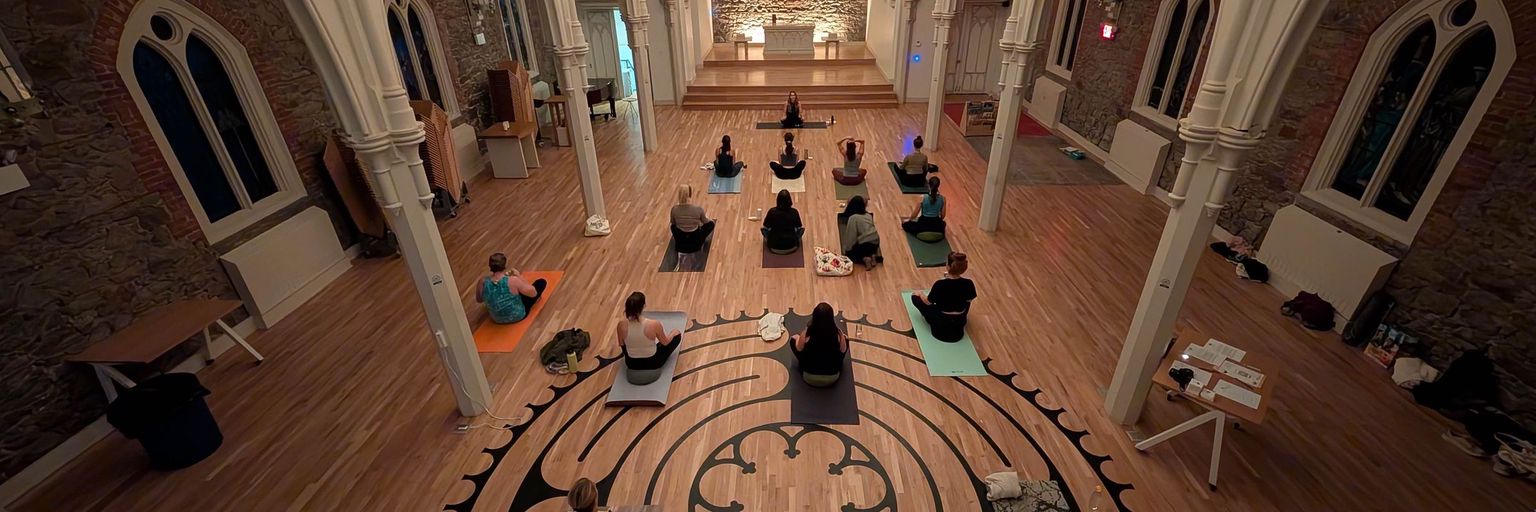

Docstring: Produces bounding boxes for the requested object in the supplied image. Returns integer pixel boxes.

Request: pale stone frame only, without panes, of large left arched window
[117,0,306,244]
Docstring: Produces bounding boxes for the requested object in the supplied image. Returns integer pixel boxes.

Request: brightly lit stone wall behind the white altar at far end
[713,0,866,43]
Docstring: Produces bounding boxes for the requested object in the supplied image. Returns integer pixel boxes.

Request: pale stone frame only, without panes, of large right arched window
[1301,0,1516,244]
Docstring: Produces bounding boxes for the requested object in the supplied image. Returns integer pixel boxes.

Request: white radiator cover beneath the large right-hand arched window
[1258,204,1398,322]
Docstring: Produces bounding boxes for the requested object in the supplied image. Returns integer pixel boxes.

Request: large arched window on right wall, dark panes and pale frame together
[1306,0,1514,243]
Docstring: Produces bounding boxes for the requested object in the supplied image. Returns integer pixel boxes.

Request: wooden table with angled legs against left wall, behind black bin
[65,298,263,401]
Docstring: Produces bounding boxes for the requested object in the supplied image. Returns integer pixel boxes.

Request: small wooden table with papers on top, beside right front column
[1137,331,1284,489]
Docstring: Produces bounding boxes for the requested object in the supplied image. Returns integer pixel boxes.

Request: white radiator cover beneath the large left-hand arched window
[220,206,352,329]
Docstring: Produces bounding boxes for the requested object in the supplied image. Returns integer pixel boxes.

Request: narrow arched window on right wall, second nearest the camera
[1135,0,1215,126]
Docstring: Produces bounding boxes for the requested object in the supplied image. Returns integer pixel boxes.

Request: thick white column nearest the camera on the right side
[1104,0,1326,424]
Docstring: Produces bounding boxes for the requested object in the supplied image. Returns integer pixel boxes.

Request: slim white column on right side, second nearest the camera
[976,0,1044,232]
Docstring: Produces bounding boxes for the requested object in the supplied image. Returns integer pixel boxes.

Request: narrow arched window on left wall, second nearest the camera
[384,0,459,115]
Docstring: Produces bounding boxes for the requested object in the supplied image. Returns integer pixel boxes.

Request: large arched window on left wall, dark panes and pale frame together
[117,0,304,241]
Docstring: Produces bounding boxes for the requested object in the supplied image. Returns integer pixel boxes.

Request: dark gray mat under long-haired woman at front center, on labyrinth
[782,315,859,424]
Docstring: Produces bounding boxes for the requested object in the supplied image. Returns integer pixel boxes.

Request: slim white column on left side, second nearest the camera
[550,0,608,220]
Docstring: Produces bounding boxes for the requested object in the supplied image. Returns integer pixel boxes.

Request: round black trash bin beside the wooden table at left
[106,374,224,469]
